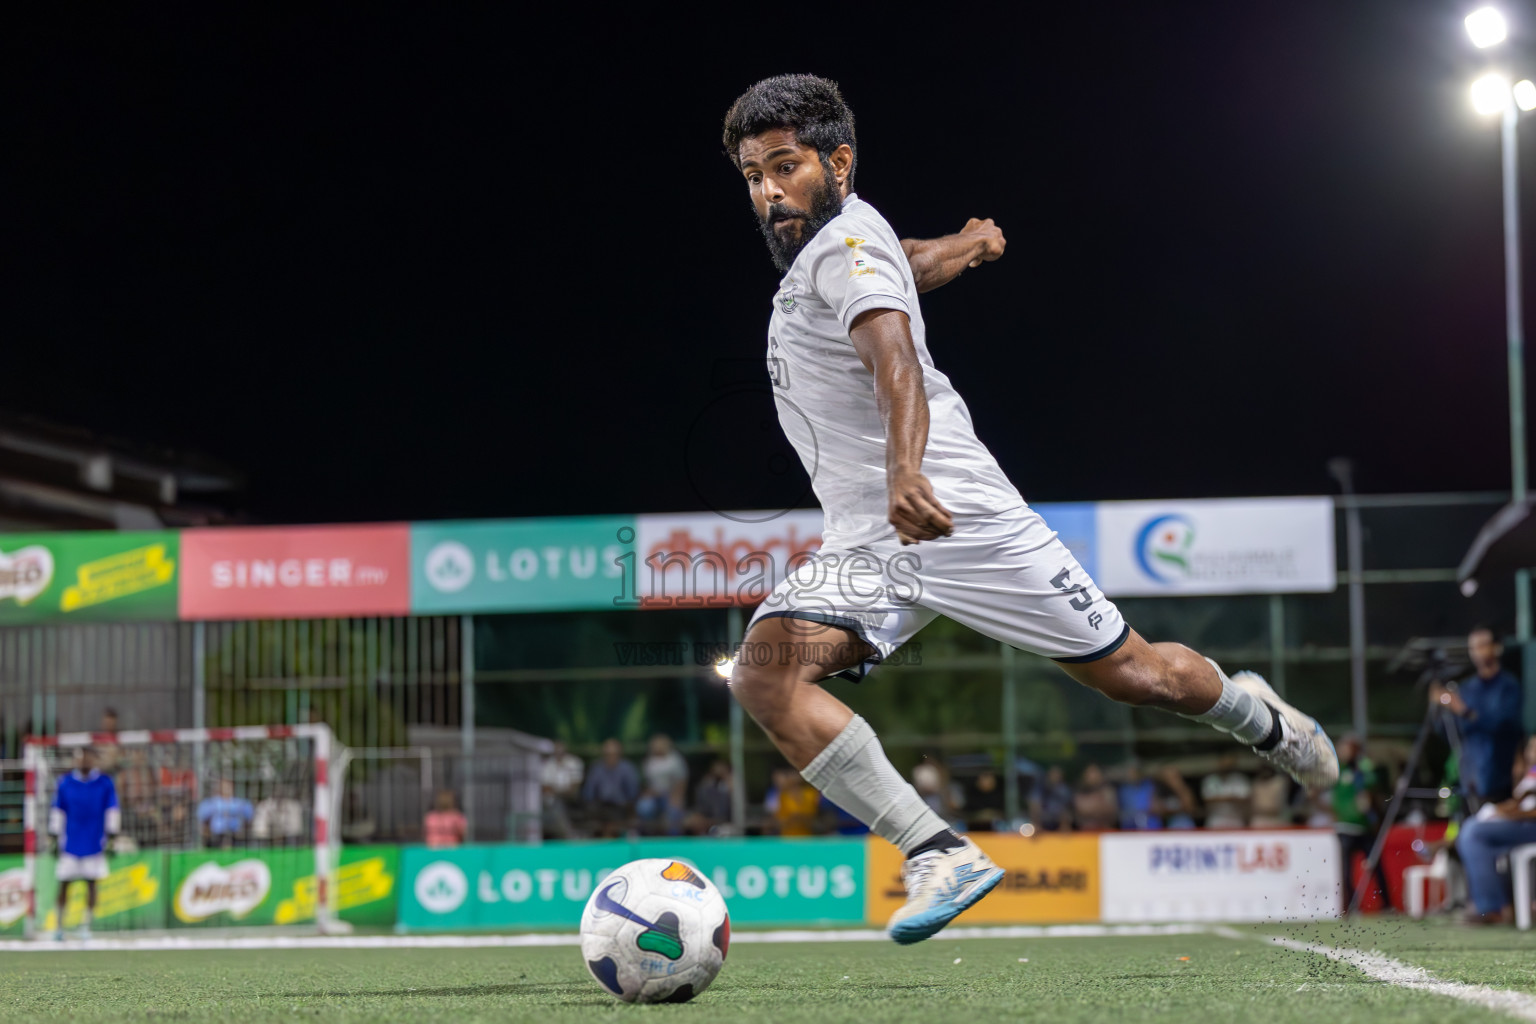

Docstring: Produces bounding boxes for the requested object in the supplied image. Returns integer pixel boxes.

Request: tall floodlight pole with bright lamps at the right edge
[1465,8,1536,645]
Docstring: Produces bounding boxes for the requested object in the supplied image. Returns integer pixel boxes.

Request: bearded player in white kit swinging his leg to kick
[722,75,1338,943]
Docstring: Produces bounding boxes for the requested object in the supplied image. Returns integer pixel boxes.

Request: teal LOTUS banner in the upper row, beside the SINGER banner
[410,516,639,616]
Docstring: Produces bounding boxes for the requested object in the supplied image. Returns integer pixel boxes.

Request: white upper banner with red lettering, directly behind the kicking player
[634,508,822,608]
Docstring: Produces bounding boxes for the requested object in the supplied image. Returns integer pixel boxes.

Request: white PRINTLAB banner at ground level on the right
[1098,829,1341,921]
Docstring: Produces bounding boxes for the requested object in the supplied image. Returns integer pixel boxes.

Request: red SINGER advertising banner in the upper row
[181,524,410,619]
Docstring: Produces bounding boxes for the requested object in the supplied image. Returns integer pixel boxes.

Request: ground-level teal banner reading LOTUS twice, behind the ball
[399,837,865,930]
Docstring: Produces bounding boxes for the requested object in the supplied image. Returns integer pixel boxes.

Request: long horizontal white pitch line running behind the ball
[0,924,1210,953]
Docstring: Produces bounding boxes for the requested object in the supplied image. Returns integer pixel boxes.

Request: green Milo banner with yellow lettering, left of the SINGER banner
[0,530,180,625]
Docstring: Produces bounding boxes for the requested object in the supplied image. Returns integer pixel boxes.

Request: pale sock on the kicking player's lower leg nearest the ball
[800,715,949,855]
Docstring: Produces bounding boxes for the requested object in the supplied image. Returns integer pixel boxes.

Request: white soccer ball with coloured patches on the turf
[581,860,731,1003]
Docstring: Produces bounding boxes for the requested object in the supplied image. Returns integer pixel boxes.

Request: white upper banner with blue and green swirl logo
[1094,497,1338,597]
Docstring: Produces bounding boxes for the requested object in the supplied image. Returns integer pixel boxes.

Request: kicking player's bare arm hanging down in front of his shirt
[848,309,954,543]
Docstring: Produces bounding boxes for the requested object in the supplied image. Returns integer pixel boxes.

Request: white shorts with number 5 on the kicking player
[739,505,1130,680]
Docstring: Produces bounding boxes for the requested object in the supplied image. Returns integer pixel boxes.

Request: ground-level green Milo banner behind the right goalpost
[166,846,399,927]
